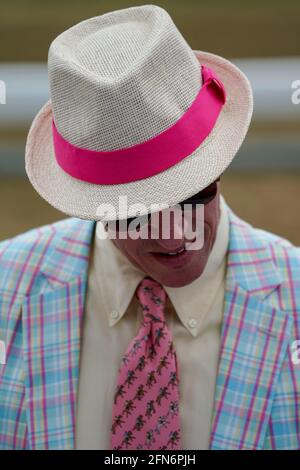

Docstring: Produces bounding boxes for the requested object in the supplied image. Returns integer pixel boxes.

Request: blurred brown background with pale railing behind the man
[0,0,300,245]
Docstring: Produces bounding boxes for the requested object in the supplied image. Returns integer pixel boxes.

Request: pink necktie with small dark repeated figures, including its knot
[111,277,181,450]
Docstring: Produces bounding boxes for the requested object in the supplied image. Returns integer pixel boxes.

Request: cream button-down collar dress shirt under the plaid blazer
[76,195,229,450]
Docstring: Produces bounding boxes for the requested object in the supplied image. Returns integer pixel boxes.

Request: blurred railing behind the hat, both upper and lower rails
[0,57,300,177]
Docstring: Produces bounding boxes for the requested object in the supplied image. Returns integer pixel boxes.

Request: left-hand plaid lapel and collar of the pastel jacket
[22,219,94,449]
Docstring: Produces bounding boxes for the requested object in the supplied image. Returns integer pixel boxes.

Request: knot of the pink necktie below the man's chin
[136,277,167,323]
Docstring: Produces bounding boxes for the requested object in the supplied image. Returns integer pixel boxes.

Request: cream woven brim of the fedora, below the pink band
[25,51,253,220]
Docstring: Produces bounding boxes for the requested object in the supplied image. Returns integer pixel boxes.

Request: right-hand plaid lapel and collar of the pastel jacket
[210,206,292,449]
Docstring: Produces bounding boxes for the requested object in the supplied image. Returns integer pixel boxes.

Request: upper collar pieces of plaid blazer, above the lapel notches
[40,205,282,299]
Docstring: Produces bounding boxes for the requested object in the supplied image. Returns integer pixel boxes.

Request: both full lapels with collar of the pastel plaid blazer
[23,206,291,449]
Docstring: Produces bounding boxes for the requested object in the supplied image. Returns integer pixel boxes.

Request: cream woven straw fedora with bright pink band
[25,5,253,220]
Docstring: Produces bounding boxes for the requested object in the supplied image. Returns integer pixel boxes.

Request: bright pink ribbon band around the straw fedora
[52,65,226,184]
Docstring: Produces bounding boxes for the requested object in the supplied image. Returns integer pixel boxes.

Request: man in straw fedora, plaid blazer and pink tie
[0,5,300,450]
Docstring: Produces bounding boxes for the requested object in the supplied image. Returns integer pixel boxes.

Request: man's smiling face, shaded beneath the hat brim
[112,179,220,287]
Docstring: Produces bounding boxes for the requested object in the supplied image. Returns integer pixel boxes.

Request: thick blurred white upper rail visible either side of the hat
[0,57,300,126]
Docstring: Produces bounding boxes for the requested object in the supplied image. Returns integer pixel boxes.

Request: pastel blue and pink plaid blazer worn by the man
[0,206,300,449]
